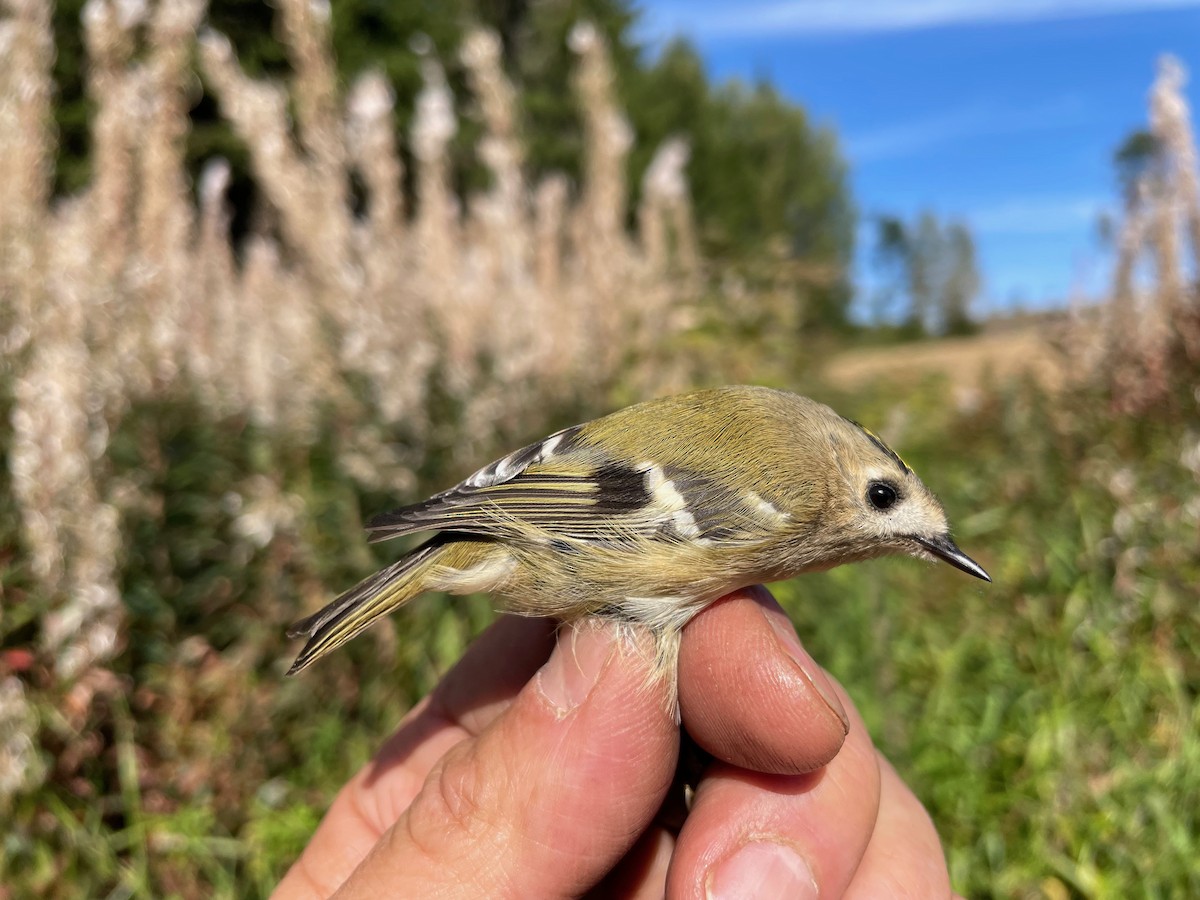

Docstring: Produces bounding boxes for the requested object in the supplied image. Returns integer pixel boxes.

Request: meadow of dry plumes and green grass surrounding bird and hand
[0,0,1200,900]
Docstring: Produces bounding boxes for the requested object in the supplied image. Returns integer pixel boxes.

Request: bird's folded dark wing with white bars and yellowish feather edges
[367,426,780,544]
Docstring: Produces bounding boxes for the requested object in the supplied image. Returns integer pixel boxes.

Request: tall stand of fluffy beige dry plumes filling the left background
[0,0,698,790]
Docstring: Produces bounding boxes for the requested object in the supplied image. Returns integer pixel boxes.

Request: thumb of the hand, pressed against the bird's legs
[338,622,678,898]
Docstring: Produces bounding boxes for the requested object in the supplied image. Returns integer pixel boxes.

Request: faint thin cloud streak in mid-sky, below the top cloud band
[844,96,1085,163]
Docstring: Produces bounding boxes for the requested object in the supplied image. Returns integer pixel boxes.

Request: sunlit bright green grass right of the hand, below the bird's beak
[778,372,1200,898]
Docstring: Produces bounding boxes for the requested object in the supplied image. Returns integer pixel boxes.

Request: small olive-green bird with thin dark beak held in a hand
[288,386,991,676]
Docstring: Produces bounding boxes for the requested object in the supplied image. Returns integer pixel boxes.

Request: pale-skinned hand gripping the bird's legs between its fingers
[275,588,954,900]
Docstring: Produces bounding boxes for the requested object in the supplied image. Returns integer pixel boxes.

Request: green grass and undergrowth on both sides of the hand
[0,372,1200,899]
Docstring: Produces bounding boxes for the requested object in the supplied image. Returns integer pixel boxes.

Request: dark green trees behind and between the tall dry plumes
[46,0,854,334]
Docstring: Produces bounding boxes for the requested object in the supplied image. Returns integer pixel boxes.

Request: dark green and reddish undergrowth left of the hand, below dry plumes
[0,386,501,898]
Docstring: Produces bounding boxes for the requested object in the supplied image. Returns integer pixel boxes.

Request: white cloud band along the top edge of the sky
[646,0,1200,38]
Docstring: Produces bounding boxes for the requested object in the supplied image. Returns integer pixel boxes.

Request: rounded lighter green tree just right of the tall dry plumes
[628,40,854,337]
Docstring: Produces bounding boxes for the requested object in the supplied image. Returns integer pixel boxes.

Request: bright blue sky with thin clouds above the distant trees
[640,0,1200,310]
